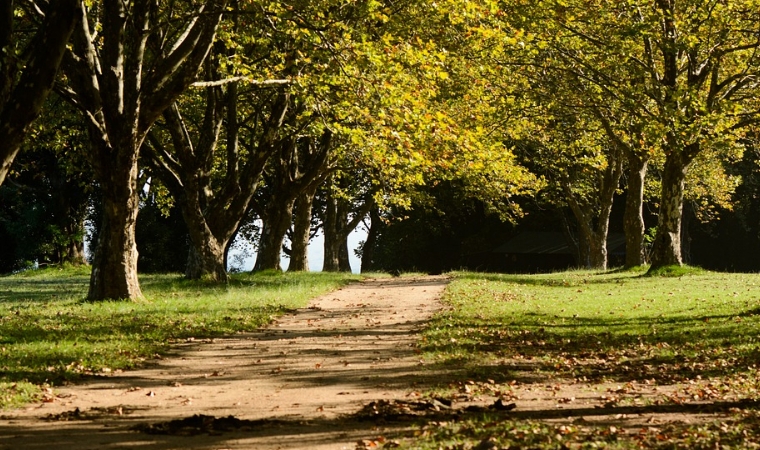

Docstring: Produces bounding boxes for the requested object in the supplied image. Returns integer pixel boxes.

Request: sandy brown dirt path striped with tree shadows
[0,277,447,450]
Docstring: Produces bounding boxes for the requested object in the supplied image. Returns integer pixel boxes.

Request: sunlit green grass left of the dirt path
[0,267,358,408]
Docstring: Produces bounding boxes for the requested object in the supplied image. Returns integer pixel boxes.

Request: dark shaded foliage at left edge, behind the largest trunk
[0,96,92,272]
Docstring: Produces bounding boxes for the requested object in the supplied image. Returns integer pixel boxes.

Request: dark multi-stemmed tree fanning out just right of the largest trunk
[145,79,290,282]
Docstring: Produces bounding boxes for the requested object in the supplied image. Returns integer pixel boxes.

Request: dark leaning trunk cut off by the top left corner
[0,0,81,185]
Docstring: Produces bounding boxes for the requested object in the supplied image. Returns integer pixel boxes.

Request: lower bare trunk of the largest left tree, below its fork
[87,163,142,300]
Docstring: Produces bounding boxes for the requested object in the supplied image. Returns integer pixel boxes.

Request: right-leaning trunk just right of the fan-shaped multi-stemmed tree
[253,197,294,272]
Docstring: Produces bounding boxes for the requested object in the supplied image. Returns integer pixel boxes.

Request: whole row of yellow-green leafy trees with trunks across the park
[0,0,760,300]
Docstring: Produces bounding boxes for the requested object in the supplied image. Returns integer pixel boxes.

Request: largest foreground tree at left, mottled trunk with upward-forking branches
[59,0,227,300]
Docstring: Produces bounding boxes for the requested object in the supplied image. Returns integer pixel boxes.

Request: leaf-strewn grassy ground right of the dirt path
[404,270,760,450]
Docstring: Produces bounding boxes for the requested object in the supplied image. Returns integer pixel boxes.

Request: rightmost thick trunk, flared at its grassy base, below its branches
[650,153,690,271]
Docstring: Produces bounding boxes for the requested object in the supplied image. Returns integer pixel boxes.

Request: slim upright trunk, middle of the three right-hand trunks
[623,153,648,269]
